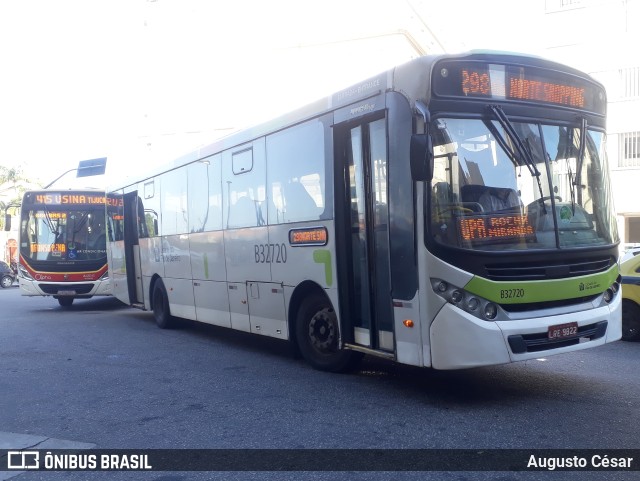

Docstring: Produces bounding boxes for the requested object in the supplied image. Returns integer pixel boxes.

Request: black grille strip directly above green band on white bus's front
[485,256,614,281]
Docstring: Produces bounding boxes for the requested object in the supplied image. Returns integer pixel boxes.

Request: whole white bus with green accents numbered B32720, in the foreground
[107,52,621,371]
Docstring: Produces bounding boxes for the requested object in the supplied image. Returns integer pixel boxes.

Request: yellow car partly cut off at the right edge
[620,251,640,341]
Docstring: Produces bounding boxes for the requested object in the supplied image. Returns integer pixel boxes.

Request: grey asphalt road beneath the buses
[0,288,640,481]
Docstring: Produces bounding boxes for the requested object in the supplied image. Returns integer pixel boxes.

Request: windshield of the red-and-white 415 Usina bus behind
[20,206,107,262]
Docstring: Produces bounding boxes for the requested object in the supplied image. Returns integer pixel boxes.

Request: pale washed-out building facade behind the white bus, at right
[541,0,640,249]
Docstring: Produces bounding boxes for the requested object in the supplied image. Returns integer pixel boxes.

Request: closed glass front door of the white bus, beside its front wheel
[336,118,394,352]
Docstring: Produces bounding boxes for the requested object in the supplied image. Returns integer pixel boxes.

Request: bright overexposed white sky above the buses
[0,0,544,188]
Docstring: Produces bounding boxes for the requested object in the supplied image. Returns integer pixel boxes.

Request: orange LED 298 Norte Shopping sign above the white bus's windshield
[433,61,606,113]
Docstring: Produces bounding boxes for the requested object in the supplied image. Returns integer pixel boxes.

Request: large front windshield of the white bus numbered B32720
[428,116,617,250]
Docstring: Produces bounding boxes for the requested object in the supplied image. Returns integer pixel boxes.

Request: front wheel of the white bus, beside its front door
[296,294,362,372]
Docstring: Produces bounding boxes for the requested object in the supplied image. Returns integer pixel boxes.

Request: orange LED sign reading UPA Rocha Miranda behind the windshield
[458,214,535,242]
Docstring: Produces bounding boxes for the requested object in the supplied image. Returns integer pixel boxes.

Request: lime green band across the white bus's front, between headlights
[464,264,618,304]
